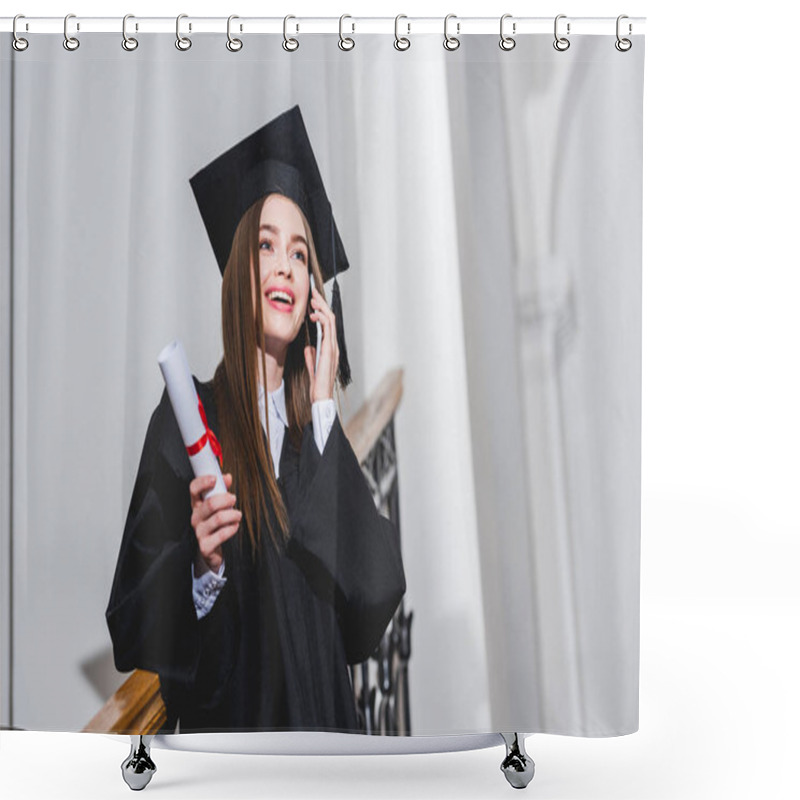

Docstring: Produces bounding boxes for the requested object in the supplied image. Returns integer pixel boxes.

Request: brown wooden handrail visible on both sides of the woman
[83,369,403,735]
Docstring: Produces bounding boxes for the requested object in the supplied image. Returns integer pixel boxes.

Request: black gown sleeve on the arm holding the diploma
[106,391,200,683]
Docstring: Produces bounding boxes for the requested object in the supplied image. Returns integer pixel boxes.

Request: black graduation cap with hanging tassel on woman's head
[189,106,351,387]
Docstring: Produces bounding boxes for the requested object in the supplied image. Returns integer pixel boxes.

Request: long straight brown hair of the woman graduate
[213,195,324,559]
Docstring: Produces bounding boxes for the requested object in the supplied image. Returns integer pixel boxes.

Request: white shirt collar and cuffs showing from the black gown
[192,381,336,619]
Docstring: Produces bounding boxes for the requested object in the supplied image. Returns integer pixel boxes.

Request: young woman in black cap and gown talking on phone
[106,107,405,732]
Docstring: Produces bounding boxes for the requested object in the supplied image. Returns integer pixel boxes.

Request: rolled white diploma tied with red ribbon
[158,339,228,497]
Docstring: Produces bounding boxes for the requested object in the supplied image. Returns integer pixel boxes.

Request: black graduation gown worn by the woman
[106,380,405,732]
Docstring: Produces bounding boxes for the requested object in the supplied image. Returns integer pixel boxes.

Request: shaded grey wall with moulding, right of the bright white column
[450,37,641,735]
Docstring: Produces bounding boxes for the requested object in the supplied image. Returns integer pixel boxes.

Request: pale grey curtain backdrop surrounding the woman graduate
[0,23,644,736]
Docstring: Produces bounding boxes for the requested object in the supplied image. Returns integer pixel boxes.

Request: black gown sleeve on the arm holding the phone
[289,417,406,664]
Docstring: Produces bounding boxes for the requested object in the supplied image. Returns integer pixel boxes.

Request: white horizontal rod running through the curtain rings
[0,15,646,36]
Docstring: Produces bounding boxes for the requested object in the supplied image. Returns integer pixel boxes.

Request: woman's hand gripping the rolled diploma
[189,473,242,577]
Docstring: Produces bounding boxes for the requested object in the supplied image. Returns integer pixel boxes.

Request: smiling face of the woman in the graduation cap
[258,194,310,356]
